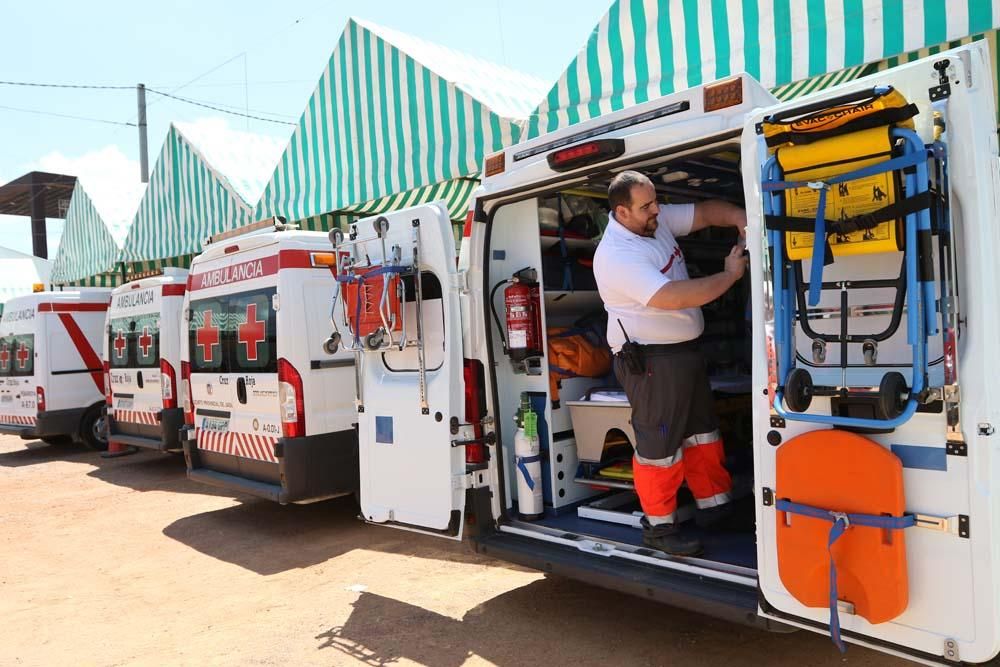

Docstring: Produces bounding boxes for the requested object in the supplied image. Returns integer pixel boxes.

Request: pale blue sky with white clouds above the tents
[0,0,610,257]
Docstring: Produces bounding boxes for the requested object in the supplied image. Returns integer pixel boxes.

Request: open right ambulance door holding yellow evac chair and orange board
[742,40,1000,664]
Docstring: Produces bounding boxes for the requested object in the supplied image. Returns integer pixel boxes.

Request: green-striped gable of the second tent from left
[118,123,262,275]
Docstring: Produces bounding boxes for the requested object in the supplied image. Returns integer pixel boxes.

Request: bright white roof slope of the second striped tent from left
[175,117,292,206]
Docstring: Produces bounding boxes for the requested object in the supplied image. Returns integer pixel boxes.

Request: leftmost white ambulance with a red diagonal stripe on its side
[0,289,111,450]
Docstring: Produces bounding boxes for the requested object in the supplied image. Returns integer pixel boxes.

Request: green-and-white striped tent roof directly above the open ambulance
[527,0,1000,137]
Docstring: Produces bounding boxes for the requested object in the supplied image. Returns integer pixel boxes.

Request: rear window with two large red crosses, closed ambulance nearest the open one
[188,287,278,373]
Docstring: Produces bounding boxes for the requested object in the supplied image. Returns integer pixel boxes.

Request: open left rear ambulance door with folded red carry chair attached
[350,203,467,540]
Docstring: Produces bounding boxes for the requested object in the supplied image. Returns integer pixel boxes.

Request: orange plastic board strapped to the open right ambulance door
[775,429,908,623]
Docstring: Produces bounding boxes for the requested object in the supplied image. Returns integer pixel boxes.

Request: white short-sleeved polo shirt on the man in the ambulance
[594,204,705,352]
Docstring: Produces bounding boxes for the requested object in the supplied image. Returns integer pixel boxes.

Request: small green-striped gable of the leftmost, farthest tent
[50,179,127,287]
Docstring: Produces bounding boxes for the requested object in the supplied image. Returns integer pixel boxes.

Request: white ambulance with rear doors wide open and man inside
[337,42,1000,664]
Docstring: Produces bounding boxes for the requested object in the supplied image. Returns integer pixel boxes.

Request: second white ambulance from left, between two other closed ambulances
[104,268,187,451]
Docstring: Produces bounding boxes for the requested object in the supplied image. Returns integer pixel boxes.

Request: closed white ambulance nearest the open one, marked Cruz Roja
[181,218,358,504]
